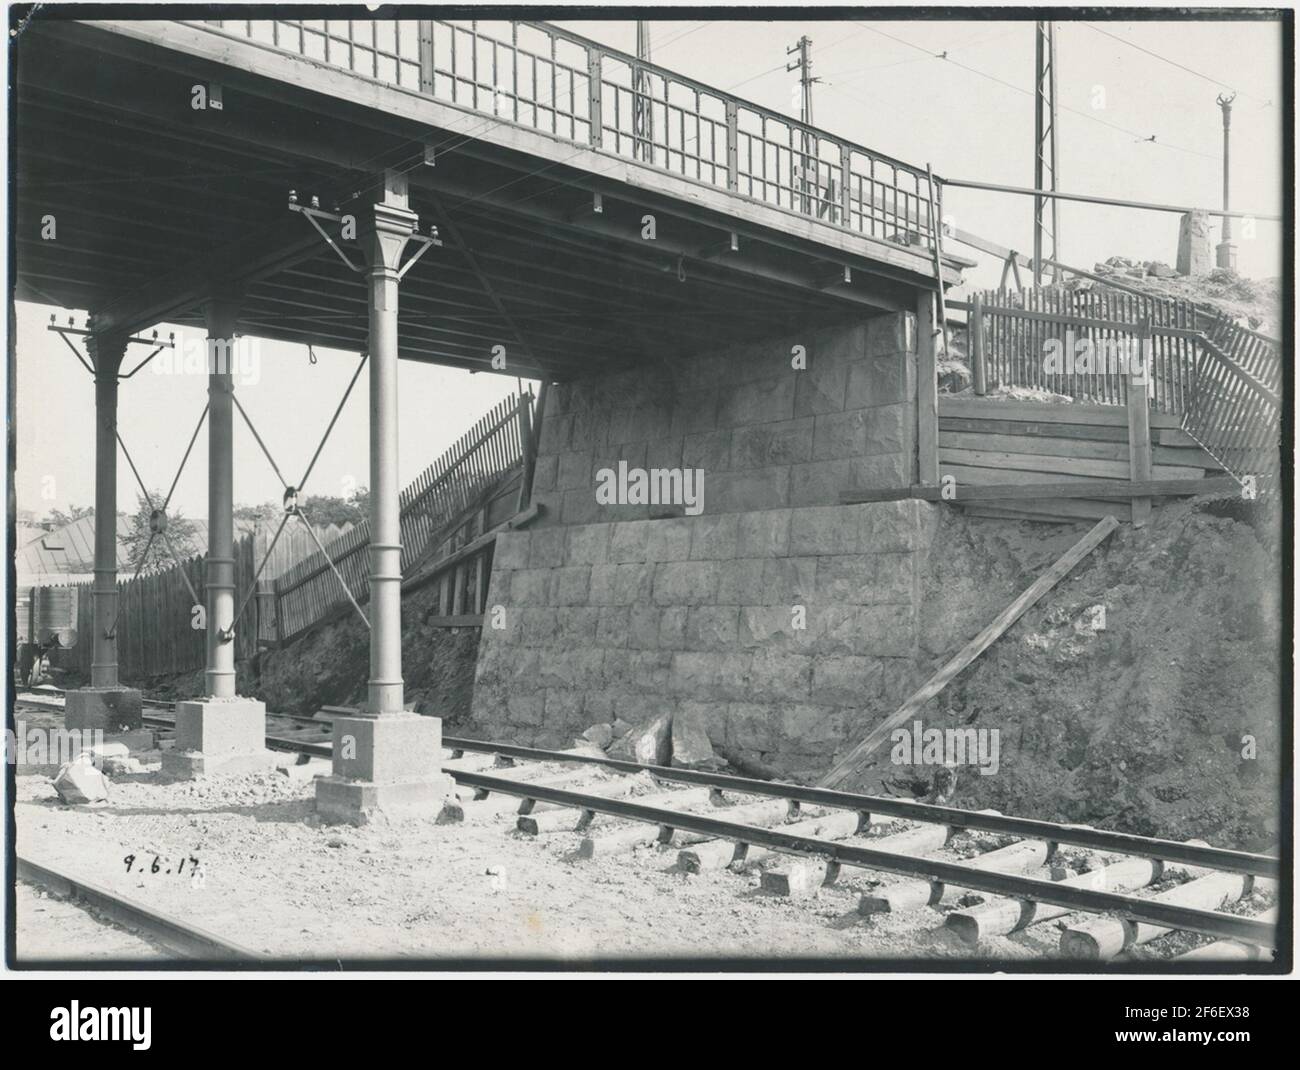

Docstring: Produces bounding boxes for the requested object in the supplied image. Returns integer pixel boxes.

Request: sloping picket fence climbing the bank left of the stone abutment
[273,393,533,642]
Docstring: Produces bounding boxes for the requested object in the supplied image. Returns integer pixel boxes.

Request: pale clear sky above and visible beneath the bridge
[16,8,1283,527]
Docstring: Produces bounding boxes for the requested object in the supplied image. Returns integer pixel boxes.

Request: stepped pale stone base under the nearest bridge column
[316,714,464,824]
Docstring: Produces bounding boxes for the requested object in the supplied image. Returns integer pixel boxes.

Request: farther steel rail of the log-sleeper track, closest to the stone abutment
[439,737,1282,879]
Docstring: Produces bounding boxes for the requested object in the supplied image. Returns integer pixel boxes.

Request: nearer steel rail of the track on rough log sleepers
[456,772,1274,944]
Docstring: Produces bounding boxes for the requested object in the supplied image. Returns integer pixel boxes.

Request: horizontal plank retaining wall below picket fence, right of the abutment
[939,395,1223,524]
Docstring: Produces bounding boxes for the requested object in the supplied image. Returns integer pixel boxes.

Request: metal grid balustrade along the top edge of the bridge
[195,18,941,246]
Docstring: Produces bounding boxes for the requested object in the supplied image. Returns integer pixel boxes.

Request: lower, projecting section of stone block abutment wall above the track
[472,501,933,776]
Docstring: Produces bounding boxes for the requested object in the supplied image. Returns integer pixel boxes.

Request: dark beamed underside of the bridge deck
[17,23,956,378]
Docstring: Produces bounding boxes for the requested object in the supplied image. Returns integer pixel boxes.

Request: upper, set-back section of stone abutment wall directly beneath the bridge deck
[533,313,917,524]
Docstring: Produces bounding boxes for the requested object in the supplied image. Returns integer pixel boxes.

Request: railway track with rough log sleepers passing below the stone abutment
[23,689,1281,961]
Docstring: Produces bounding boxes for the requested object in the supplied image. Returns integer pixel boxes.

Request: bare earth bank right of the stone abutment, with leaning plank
[878,503,1287,848]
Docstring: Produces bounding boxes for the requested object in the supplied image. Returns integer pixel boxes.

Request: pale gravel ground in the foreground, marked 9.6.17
[16,763,1086,962]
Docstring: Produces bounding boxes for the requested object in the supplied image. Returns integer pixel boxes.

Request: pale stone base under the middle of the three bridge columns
[163,698,276,780]
